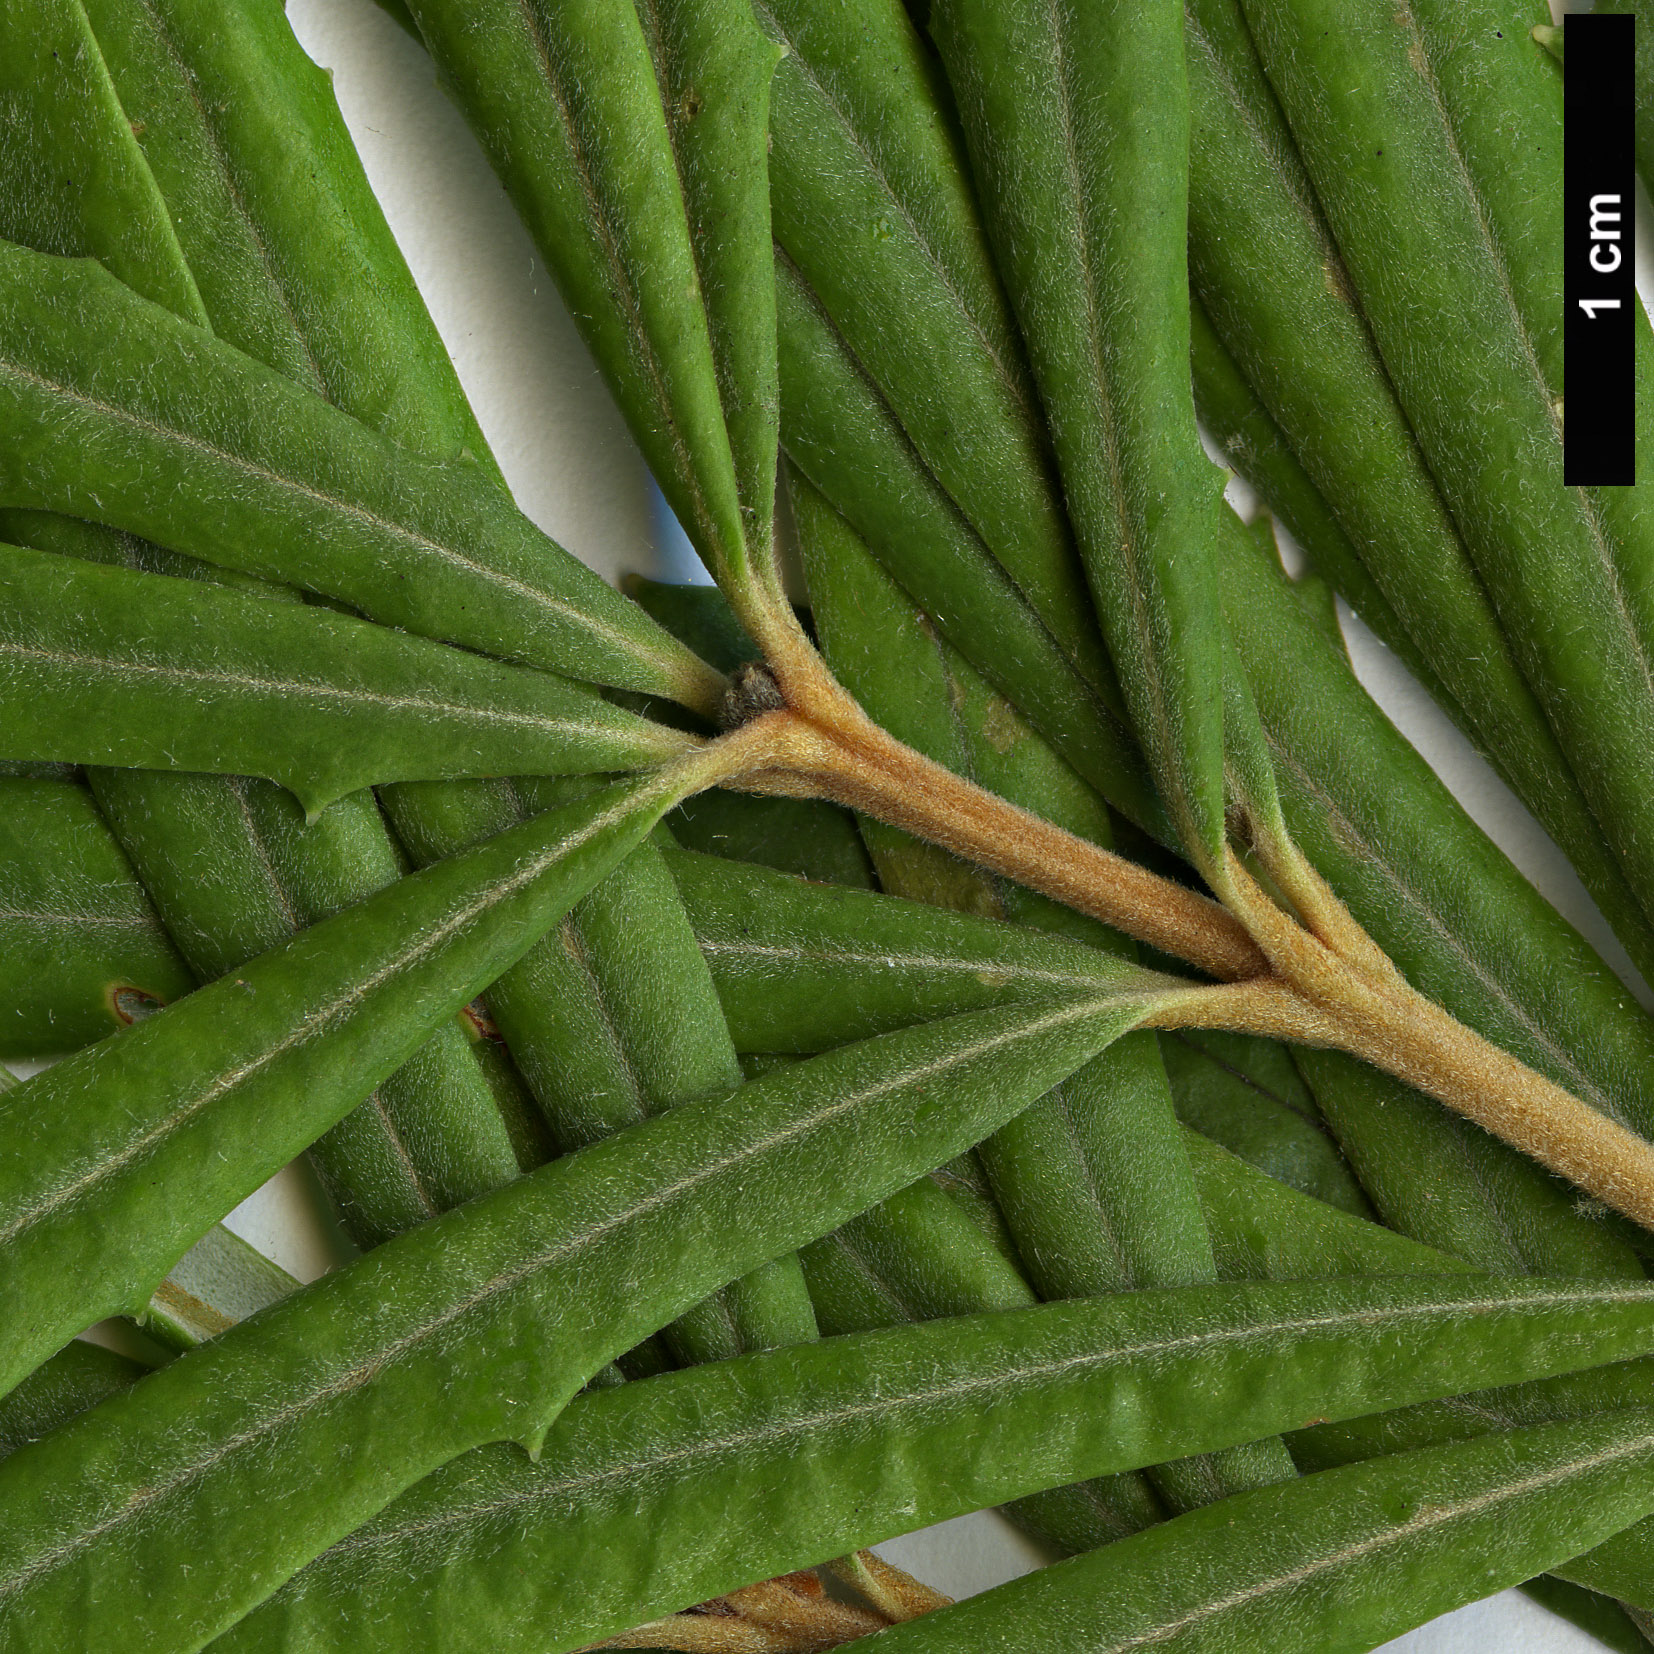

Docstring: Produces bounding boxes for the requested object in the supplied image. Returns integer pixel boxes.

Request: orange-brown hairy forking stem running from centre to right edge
[673,664,1654,1229]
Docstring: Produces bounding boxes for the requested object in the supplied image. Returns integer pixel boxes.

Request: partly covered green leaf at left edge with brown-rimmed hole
[0,776,194,1057]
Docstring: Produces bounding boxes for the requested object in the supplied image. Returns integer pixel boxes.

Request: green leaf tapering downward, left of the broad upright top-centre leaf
[758,0,1118,705]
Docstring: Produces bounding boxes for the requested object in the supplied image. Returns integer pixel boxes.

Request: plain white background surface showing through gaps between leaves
[48,0,1647,1654]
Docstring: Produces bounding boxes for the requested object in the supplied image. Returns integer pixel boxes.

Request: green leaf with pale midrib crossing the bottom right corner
[885,1409,1654,1654]
